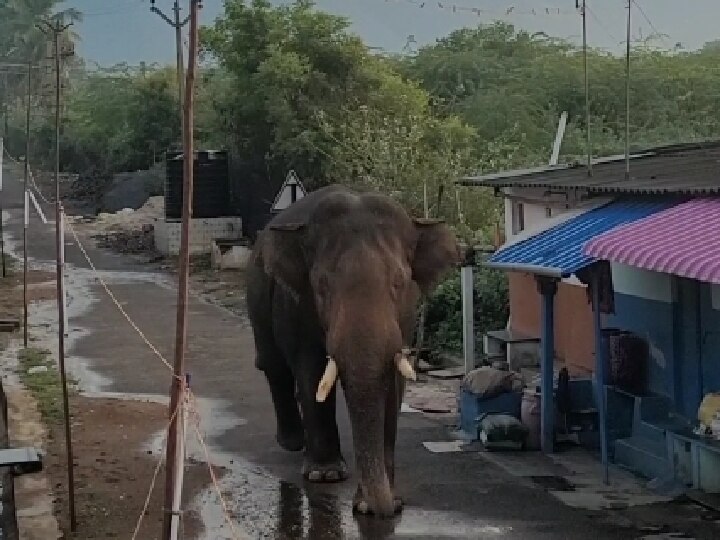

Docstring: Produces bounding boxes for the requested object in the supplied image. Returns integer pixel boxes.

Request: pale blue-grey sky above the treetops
[64,0,720,65]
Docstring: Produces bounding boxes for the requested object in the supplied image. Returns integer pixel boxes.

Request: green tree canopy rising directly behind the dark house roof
[401,23,720,162]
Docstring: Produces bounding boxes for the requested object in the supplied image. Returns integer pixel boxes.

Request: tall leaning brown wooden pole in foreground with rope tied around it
[162,0,201,540]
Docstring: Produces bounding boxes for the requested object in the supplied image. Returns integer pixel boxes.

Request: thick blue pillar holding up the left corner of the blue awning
[537,277,557,454]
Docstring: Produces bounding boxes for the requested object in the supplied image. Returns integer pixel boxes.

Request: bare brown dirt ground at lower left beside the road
[46,396,208,540]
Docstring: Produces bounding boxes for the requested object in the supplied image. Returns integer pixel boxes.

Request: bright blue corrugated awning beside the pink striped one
[486,199,679,278]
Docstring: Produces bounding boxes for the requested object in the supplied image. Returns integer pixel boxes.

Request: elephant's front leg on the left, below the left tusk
[297,356,348,482]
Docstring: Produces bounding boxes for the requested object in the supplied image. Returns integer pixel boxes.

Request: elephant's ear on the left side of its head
[260,223,308,300]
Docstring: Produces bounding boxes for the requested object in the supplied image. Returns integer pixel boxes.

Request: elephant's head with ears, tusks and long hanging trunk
[261,188,461,515]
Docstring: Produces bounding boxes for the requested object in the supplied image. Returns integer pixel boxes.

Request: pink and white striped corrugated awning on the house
[583,198,720,284]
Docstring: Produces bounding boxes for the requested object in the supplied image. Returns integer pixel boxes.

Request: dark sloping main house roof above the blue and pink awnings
[460,142,720,195]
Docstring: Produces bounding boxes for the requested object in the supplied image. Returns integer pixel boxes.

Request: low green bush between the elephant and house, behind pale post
[425,266,509,353]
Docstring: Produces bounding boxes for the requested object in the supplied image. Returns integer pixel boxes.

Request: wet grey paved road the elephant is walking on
[3,162,660,540]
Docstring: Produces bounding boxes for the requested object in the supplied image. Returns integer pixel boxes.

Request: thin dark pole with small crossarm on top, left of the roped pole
[41,19,77,532]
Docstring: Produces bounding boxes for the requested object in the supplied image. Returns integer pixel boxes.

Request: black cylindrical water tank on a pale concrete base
[165,151,230,220]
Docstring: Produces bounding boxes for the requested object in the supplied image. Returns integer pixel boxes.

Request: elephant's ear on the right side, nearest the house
[412,219,462,294]
